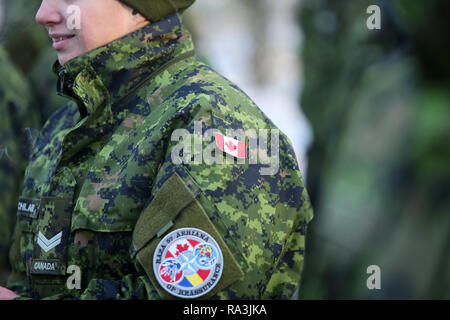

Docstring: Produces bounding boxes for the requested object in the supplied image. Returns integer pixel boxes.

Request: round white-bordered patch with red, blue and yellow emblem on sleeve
[153,228,223,299]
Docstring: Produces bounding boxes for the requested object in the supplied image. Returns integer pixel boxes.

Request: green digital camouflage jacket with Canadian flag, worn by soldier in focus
[8,15,312,299]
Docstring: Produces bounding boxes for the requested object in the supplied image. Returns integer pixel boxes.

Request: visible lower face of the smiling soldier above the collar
[36,0,148,65]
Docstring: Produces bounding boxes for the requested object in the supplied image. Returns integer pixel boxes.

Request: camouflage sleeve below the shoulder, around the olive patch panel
[130,99,313,299]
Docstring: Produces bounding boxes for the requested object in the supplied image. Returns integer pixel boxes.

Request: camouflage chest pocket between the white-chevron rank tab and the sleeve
[68,175,151,290]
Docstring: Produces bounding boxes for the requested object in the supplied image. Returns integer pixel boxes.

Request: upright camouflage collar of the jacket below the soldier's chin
[53,14,194,118]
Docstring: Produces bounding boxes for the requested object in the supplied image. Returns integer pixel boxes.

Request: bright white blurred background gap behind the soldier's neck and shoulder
[186,0,313,178]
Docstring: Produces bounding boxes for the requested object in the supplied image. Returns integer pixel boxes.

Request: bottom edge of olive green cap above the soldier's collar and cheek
[119,0,195,22]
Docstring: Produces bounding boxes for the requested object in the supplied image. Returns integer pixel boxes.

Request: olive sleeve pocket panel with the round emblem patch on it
[133,173,243,299]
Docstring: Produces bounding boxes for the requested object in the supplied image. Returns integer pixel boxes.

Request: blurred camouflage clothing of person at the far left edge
[0,46,35,285]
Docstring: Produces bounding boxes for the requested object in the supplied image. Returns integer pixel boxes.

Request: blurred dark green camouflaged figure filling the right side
[300,0,450,299]
